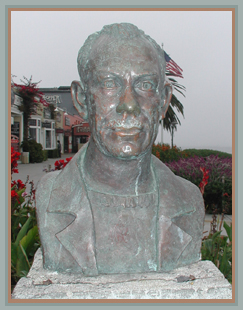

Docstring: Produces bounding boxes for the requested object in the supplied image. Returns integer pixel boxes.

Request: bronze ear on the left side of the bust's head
[71,81,88,120]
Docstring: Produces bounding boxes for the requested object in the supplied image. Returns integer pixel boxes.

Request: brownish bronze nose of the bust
[116,88,141,116]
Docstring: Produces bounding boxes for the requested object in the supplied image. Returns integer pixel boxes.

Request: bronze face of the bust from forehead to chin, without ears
[86,36,164,159]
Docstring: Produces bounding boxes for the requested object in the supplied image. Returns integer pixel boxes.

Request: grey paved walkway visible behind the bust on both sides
[12,153,232,236]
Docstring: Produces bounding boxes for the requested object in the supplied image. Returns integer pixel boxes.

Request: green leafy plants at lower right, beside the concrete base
[201,222,232,283]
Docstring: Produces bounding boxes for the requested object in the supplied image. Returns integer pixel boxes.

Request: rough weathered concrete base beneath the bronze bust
[12,249,232,299]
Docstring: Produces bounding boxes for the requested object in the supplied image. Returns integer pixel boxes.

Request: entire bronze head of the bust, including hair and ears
[71,24,171,159]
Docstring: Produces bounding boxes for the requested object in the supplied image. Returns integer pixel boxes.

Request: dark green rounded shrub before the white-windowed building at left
[21,139,45,163]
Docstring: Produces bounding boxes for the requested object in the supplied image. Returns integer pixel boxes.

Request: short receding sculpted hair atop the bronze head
[77,23,166,92]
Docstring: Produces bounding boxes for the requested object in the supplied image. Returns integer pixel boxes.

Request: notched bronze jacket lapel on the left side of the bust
[47,147,98,275]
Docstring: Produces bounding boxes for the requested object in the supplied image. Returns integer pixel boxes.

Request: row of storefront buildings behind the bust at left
[11,86,90,153]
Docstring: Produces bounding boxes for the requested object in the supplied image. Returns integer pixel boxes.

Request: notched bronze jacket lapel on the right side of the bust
[153,157,195,271]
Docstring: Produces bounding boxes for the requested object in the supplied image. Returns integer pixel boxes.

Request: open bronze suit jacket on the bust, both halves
[36,145,205,275]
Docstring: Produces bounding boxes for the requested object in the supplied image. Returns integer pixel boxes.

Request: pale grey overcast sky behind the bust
[11,11,232,151]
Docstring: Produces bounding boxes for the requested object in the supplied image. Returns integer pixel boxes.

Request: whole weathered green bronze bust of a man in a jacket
[36,23,204,276]
